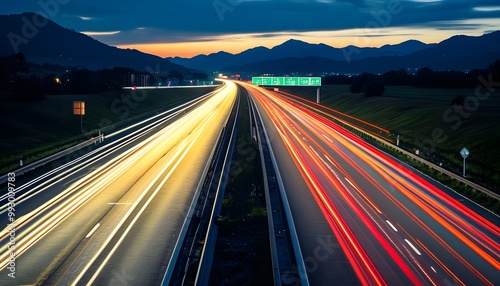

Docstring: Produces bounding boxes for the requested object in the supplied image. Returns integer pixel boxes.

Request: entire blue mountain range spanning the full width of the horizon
[0,13,500,74]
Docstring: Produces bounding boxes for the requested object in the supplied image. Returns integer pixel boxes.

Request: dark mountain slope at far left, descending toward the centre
[0,13,187,72]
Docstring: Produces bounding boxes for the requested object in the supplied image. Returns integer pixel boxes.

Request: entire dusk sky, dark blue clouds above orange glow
[0,0,500,58]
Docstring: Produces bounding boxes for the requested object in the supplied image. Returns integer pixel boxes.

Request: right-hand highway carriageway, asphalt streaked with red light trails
[241,83,500,285]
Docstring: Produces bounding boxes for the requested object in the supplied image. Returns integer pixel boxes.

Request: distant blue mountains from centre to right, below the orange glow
[168,31,500,74]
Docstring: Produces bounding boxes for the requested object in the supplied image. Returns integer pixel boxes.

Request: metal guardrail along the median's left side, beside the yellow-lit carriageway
[161,85,239,285]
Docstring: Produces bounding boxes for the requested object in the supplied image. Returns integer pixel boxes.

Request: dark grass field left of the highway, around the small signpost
[0,87,219,173]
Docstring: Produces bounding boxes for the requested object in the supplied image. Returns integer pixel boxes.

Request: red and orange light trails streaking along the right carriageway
[242,81,500,285]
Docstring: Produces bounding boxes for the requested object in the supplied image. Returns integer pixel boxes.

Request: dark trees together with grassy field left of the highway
[0,54,214,174]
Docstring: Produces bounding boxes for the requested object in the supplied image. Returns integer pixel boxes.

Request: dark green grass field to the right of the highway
[280,85,500,192]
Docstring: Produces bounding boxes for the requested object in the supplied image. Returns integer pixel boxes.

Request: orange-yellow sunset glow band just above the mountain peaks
[116,24,500,58]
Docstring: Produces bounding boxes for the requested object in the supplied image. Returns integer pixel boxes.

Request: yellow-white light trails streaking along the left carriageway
[0,82,237,284]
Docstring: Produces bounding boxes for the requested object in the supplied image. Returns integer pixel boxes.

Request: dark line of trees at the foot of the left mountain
[0,53,208,101]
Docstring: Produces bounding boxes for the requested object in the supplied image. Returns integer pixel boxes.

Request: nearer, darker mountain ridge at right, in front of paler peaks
[220,31,500,74]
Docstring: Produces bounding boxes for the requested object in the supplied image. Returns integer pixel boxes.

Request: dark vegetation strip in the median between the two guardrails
[209,97,274,285]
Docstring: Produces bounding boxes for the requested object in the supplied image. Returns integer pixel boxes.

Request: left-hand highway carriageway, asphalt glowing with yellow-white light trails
[0,82,237,285]
